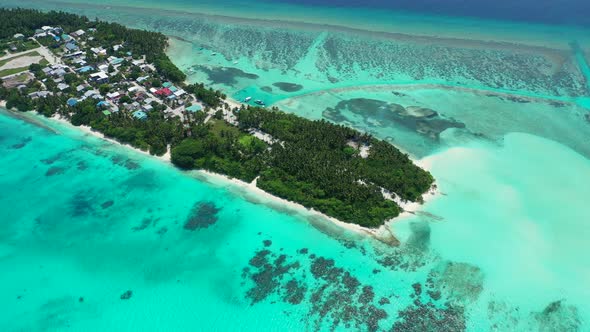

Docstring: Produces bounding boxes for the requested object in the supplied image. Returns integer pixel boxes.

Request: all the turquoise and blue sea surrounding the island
[0,0,590,331]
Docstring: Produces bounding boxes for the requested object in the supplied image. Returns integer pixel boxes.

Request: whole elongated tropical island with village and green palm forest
[0,9,434,228]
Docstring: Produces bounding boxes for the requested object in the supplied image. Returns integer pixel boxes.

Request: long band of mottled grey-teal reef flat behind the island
[33,4,587,97]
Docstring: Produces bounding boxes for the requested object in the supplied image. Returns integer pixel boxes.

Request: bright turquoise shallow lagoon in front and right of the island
[0,108,590,331]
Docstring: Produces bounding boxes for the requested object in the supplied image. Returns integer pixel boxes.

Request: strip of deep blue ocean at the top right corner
[266,0,590,26]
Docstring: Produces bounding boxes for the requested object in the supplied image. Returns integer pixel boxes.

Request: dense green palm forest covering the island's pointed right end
[172,107,434,227]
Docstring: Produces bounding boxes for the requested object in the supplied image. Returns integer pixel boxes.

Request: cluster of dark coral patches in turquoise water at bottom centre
[242,239,476,331]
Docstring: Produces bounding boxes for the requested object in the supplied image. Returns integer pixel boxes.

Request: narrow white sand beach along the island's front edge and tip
[10,107,439,246]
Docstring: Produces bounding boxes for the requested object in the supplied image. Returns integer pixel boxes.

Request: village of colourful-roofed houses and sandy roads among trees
[0,26,240,128]
